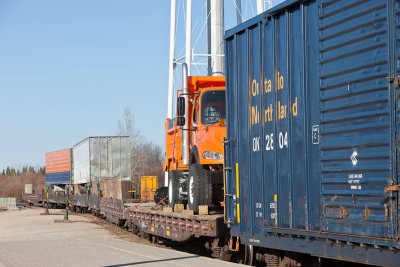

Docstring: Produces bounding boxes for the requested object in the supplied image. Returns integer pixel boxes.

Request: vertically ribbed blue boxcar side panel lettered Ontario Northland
[225,0,320,243]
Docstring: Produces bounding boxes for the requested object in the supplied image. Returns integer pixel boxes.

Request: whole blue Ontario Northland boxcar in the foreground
[225,0,400,266]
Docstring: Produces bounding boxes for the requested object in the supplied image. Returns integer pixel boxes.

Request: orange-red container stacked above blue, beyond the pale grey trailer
[45,148,72,173]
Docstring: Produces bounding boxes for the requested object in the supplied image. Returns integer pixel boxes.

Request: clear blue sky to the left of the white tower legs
[0,0,282,168]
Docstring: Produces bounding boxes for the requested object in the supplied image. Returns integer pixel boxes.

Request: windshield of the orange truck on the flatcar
[201,90,225,124]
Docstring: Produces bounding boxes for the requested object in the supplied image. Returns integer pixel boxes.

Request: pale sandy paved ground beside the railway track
[0,208,239,267]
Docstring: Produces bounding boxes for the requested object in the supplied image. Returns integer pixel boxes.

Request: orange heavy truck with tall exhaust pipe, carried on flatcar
[165,64,226,211]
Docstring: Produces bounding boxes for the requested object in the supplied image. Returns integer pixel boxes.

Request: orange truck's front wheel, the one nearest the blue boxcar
[188,164,212,211]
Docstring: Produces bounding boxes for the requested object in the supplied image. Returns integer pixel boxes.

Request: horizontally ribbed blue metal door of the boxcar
[319,1,396,237]
